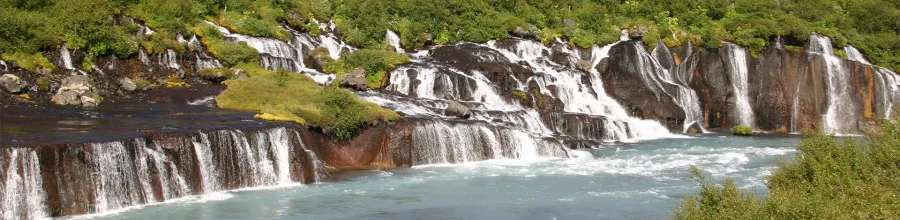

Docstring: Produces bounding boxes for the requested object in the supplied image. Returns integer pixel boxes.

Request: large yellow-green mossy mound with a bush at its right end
[216,65,400,140]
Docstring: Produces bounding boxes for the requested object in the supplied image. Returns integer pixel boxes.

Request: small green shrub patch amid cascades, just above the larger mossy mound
[325,49,409,89]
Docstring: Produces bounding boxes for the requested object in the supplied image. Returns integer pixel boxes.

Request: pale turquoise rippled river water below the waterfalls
[75,136,798,219]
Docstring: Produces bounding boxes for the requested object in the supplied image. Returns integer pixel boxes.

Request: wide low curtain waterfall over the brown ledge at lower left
[0,128,327,219]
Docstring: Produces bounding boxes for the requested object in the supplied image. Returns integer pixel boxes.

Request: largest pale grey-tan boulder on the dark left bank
[51,75,101,107]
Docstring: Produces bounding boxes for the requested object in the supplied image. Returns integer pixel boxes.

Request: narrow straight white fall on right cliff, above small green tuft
[725,42,756,128]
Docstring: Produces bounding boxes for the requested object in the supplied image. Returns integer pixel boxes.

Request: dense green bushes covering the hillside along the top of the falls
[0,0,900,70]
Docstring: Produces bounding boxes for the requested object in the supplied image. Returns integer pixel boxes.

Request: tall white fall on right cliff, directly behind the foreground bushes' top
[807,33,859,135]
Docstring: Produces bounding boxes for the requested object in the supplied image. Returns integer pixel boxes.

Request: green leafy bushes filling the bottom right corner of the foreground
[675,121,900,219]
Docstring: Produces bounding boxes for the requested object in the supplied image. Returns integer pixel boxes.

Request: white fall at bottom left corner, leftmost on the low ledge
[0,148,47,219]
